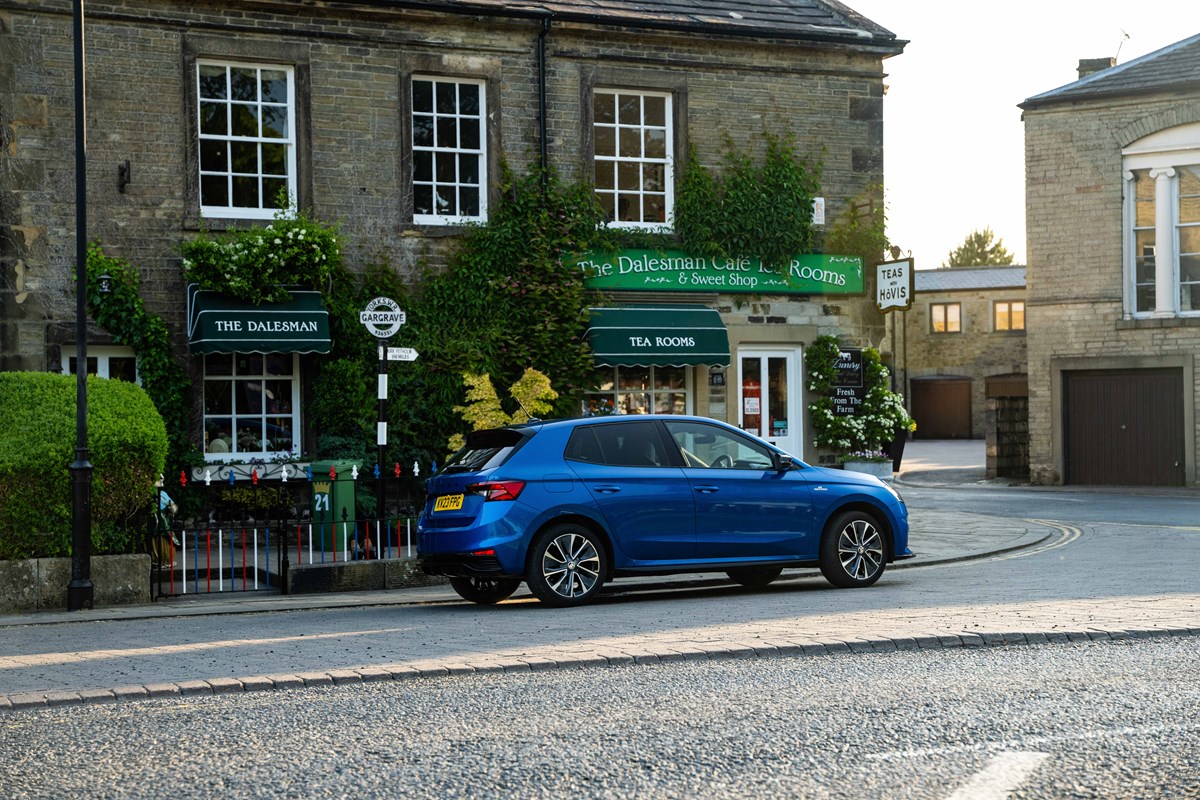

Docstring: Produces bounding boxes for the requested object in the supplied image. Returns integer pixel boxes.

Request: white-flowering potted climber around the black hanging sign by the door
[805,336,916,477]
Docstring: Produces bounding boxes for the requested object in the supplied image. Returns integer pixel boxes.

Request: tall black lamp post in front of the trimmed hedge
[67,0,94,610]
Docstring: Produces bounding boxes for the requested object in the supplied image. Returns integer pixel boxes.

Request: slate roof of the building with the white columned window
[1020,34,1200,108]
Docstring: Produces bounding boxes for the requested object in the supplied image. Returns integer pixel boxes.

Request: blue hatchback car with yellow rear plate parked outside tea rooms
[418,415,912,606]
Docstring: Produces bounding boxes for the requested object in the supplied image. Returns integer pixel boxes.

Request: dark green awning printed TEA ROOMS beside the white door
[588,305,730,367]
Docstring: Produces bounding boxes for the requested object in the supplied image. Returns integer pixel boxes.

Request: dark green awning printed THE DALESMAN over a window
[187,283,329,353]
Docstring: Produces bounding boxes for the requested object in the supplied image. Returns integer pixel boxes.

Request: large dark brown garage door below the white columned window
[1062,369,1183,486]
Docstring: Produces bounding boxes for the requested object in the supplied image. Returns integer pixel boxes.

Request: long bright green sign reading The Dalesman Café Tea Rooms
[574,249,864,294]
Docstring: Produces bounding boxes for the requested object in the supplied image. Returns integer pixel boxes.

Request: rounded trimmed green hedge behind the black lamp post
[0,372,167,559]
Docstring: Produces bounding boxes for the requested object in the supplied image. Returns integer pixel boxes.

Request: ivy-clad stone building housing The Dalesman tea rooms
[0,0,905,470]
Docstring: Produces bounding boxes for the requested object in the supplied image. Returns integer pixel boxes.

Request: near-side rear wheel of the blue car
[526,523,608,608]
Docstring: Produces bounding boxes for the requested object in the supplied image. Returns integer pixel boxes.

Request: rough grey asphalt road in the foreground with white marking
[0,638,1200,800]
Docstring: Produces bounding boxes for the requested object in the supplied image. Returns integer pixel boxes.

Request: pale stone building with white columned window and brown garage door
[1021,35,1200,486]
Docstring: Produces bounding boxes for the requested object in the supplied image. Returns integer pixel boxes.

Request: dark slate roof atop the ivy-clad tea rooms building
[380,0,907,48]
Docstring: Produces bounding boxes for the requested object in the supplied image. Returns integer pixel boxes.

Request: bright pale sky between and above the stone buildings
[842,0,1200,269]
